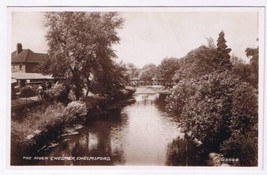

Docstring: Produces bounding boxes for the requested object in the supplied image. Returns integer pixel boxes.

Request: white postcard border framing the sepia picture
[0,0,267,174]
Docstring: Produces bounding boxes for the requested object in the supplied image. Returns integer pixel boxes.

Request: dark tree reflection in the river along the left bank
[39,108,125,165]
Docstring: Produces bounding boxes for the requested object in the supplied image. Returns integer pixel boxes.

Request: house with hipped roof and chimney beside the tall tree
[11,43,48,73]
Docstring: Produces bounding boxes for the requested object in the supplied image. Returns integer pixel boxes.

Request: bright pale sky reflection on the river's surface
[124,94,183,165]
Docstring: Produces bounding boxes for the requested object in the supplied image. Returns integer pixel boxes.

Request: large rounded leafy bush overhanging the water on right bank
[168,71,239,151]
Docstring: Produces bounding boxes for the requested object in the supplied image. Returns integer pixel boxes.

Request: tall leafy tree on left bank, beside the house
[41,12,123,99]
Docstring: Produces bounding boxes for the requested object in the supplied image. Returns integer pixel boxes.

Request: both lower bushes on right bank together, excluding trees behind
[167,71,258,165]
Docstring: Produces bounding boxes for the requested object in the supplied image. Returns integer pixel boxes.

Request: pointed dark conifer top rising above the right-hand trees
[213,31,232,71]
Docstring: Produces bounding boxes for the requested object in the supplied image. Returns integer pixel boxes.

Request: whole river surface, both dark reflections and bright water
[28,87,186,166]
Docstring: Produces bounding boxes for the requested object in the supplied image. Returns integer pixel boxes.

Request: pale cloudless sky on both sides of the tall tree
[11,10,259,67]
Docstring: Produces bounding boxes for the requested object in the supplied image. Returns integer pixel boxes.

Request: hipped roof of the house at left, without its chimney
[11,49,48,63]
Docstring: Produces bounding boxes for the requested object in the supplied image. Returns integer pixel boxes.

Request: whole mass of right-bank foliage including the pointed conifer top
[166,32,258,166]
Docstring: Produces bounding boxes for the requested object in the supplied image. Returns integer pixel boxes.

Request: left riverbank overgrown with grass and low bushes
[11,89,135,165]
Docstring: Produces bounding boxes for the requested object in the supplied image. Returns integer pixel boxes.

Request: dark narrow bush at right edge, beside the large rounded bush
[221,83,258,166]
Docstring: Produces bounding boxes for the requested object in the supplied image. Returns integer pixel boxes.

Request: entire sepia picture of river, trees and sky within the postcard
[8,7,265,169]
